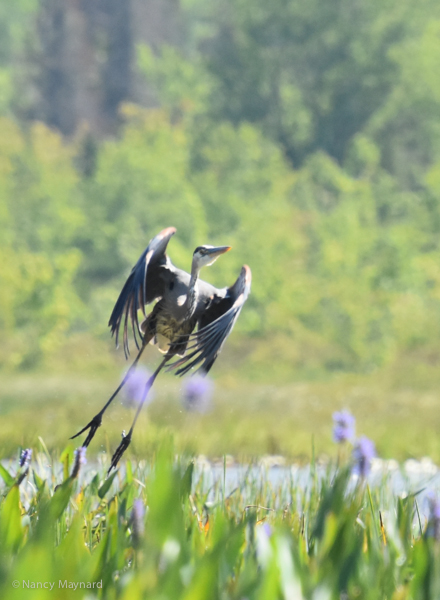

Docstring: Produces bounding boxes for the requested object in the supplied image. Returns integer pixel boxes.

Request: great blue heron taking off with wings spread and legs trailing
[72,227,251,471]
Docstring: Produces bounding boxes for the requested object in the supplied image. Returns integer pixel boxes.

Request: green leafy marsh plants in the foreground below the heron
[0,444,440,600]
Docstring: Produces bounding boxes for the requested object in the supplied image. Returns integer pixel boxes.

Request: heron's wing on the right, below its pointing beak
[168,265,252,376]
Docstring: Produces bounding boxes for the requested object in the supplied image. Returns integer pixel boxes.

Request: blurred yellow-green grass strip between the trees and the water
[4,370,440,464]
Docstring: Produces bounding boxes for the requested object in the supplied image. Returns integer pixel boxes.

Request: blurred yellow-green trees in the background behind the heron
[0,0,440,377]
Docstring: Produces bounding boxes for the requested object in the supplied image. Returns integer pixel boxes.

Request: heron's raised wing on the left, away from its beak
[108,227,176,357]
